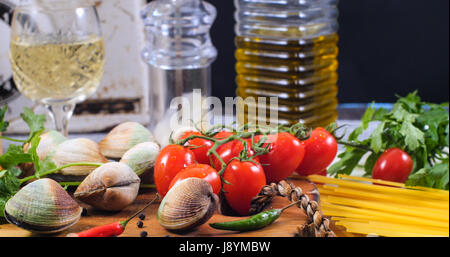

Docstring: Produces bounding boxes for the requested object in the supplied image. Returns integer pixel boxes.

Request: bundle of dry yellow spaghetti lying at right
[308,175,449,237]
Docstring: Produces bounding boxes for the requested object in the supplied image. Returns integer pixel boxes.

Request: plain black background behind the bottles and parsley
[208,0,449,103]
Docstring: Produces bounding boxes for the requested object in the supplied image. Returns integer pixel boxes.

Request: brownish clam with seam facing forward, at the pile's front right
[74,162,141,211]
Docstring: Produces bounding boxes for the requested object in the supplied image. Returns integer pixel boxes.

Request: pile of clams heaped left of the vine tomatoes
[4,122,160,233]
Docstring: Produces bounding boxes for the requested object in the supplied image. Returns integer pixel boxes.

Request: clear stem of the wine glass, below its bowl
[45,103,75,137]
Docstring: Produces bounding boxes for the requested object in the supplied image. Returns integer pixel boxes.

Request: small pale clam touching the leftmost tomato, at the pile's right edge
[120,142,160,176]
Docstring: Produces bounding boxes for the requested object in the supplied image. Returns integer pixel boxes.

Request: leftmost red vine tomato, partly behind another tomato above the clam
[154,145,195,196]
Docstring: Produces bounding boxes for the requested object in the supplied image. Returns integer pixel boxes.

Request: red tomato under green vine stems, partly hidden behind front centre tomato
[211,139,254,170]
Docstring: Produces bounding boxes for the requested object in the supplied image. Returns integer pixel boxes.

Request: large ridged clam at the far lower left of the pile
[4,178,82,234]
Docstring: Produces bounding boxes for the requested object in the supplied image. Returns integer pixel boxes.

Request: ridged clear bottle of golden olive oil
[235,0,338,127]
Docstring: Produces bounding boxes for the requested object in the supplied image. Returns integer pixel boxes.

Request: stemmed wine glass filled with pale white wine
[10,0,105,136]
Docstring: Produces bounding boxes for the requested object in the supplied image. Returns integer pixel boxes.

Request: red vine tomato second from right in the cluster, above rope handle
[257,132,305,183]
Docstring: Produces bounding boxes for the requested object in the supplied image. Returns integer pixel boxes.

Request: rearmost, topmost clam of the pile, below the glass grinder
[99,122,156,159]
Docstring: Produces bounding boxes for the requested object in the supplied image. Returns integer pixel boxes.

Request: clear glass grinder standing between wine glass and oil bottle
[142,0,217,145]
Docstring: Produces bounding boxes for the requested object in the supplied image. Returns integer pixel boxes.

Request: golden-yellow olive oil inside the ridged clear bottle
[236,33,338,127]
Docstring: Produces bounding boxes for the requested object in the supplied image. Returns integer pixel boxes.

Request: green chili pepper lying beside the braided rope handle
[209,199,298,232]
